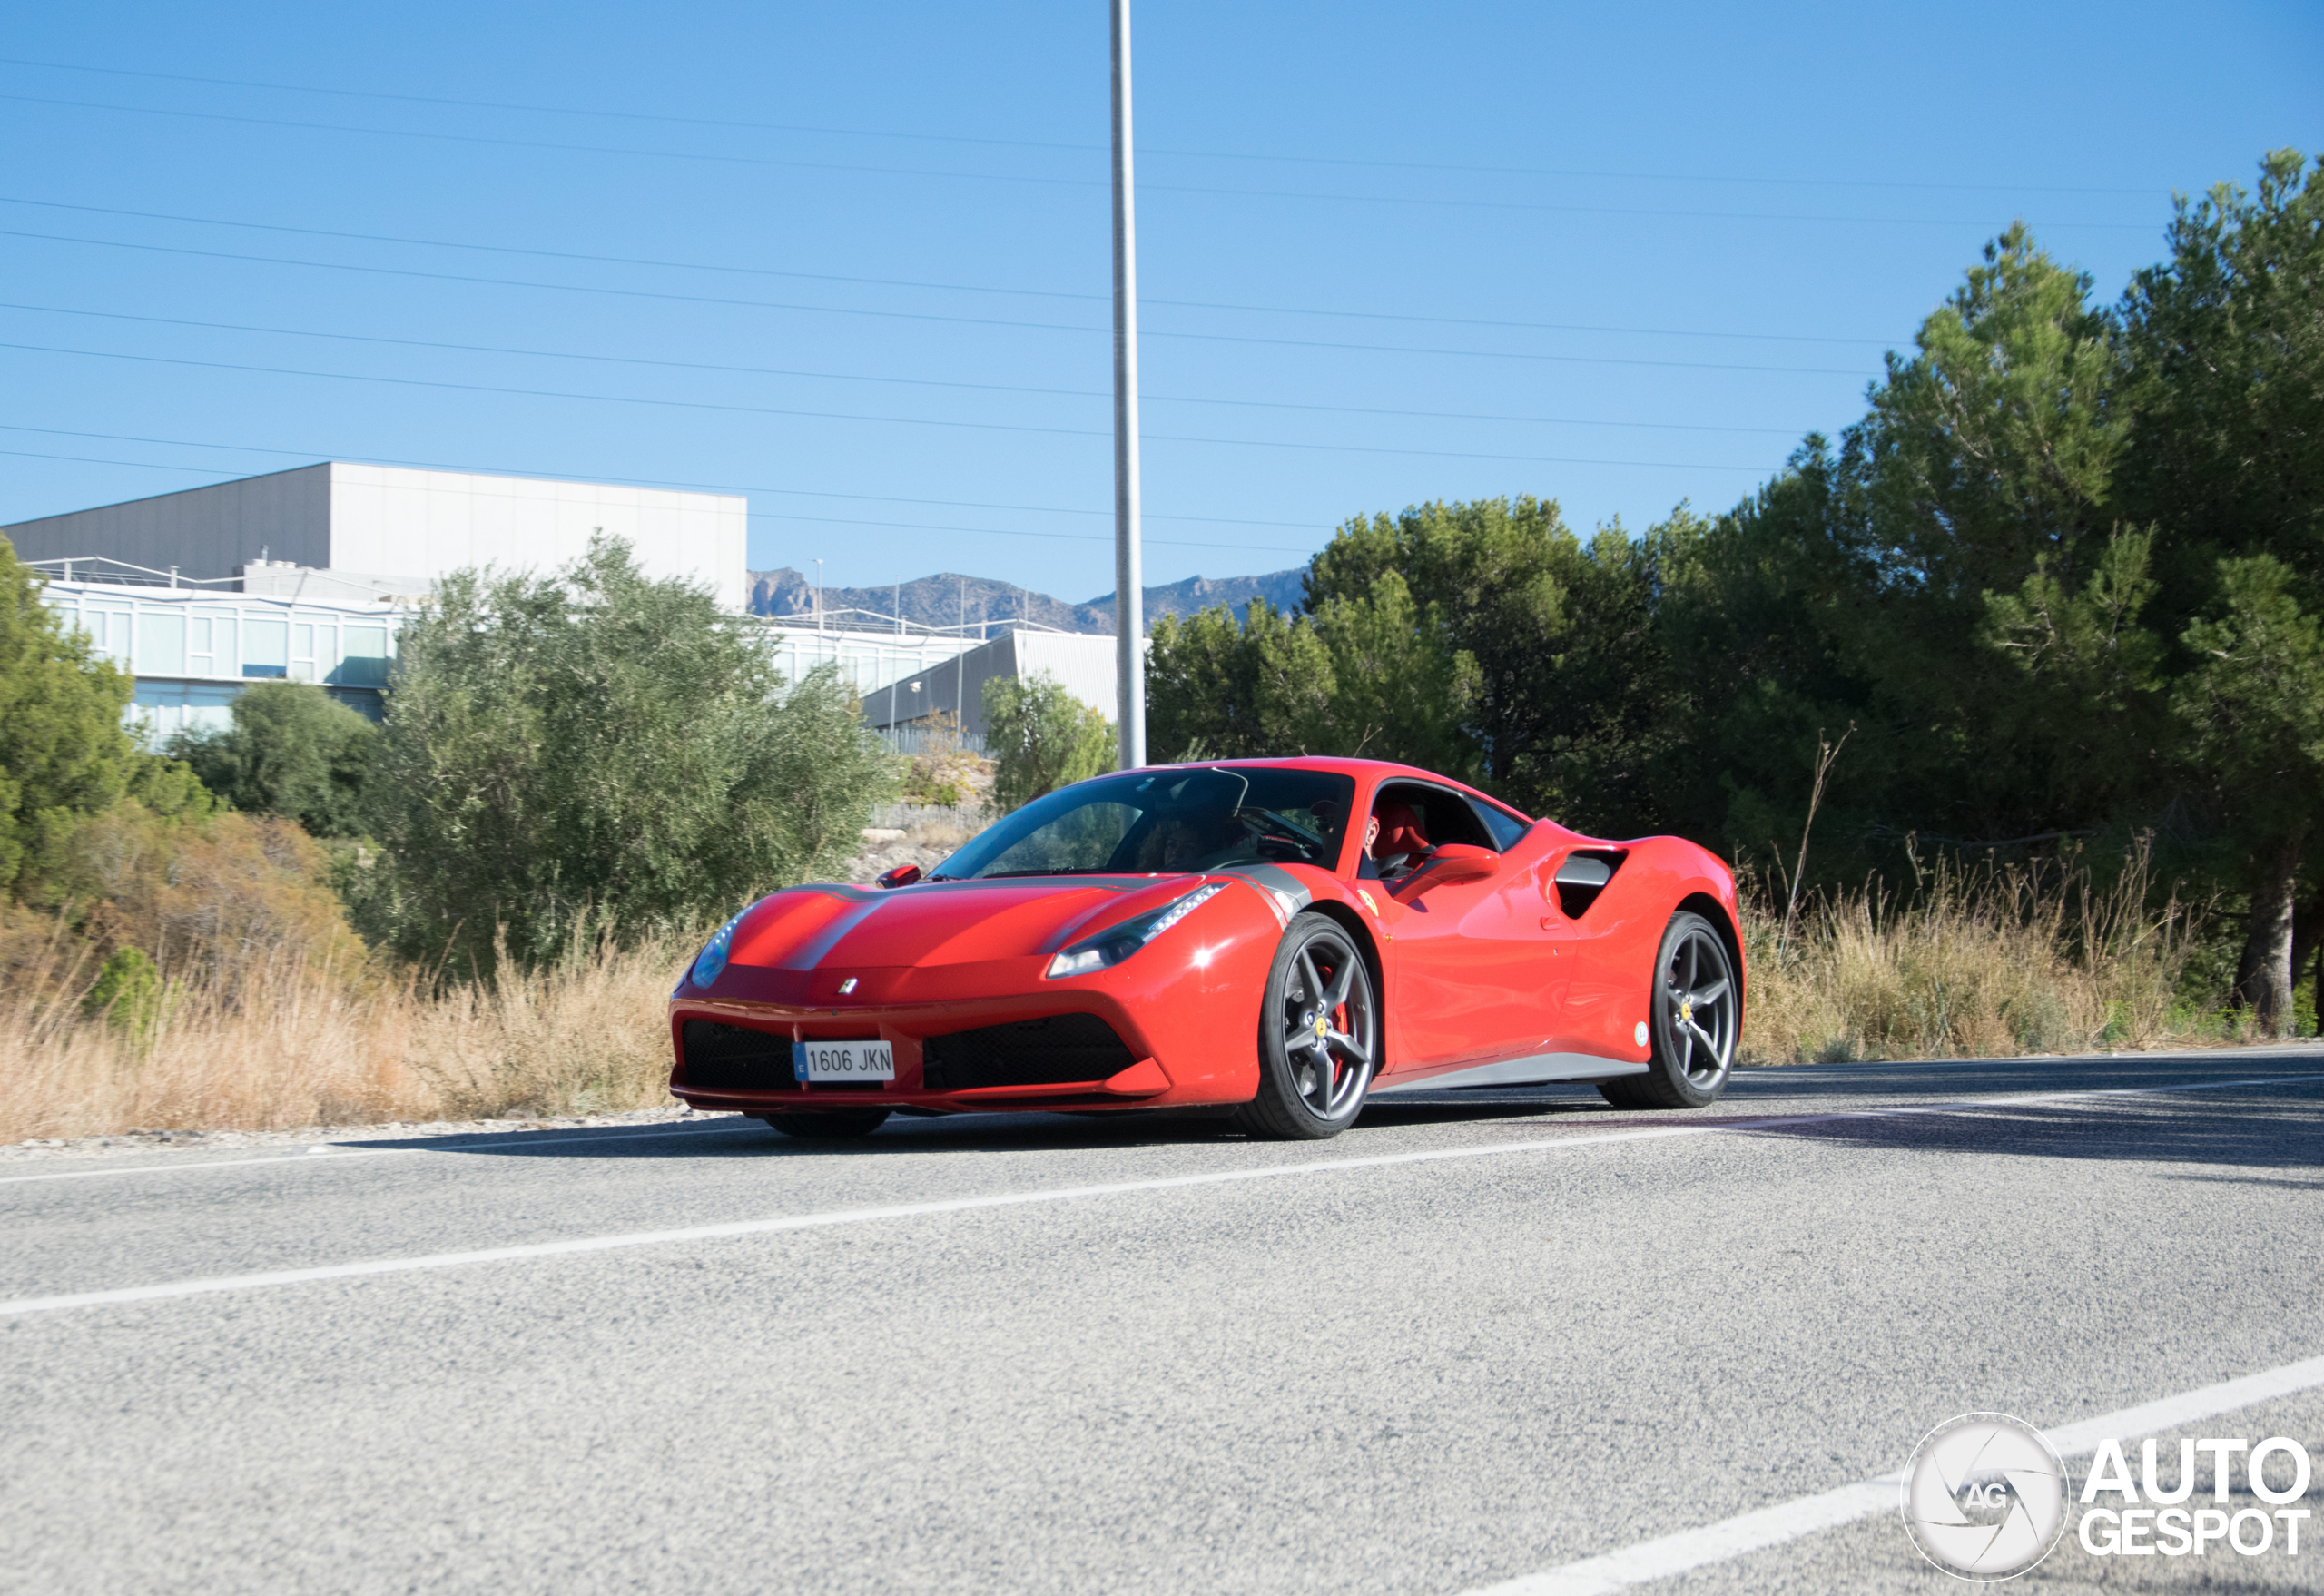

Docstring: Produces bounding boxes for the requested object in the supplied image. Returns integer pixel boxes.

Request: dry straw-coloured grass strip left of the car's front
[0,941,693,1140]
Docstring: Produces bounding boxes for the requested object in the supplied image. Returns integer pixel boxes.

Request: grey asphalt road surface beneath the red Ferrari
[0,1048,2324,1596]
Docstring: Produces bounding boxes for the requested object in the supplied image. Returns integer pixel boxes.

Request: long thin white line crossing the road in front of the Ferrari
[0,1076,2324,1317]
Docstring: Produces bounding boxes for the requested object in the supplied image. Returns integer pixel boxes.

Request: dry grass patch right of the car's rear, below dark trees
[1743,848,2221,1064]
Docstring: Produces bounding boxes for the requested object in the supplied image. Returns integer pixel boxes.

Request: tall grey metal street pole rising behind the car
[1107,0,1146,772]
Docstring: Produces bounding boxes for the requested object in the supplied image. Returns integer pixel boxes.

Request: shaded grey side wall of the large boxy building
[0,465,330,578]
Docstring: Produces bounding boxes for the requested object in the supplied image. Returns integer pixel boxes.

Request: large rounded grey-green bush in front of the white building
[351,539,895,976]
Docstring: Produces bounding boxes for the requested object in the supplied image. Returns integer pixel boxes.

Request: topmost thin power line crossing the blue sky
[0,55,2162,195]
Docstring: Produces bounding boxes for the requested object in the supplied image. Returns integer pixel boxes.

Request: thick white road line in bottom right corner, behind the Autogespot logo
[1466,1356,2324,1596]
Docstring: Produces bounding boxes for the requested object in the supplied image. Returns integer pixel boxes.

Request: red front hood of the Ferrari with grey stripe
[730,876,1199,971]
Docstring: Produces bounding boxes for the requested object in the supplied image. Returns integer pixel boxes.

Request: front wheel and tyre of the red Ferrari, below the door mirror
[1234,913,1381,1140]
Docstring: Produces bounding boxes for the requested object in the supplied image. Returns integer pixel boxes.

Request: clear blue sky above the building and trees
[0,0,2324,599]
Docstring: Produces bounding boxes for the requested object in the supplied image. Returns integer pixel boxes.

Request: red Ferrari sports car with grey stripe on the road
[669,760,1743,1136]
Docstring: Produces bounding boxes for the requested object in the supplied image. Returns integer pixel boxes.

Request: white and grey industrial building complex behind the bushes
[0,460,1138,741]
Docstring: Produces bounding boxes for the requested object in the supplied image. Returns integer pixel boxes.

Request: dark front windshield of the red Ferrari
[932,764,1354,881]
